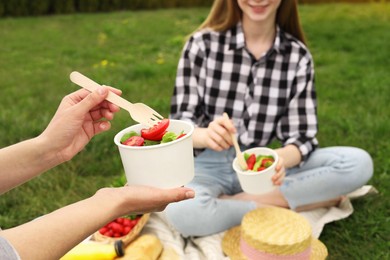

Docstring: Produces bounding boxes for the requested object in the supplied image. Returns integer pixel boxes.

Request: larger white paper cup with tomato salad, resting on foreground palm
[114,119,194,189]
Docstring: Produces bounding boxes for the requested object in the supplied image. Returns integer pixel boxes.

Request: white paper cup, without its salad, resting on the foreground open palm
[114,119,194,189]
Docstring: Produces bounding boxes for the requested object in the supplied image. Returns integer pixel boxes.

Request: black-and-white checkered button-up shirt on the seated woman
[170,23,318,159]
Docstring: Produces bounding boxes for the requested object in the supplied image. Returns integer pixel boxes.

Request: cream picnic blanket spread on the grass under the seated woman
[142,185,377,260]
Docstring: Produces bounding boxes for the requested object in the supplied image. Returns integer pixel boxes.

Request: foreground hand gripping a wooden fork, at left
[39,87,121,163]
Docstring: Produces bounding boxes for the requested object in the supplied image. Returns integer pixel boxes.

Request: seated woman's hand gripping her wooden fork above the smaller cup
[193,116,236,151]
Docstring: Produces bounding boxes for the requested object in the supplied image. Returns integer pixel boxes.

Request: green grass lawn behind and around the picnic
[0,3,390,259]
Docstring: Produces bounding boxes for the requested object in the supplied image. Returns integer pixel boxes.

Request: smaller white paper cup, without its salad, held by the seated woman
[232,147,279,195]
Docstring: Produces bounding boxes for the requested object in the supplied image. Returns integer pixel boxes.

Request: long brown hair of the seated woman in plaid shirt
[198,0,306,44]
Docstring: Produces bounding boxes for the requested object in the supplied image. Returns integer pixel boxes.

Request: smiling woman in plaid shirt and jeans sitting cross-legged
[166,0,373,236]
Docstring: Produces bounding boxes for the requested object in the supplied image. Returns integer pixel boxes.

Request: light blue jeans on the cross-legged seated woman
[165,147,373,237]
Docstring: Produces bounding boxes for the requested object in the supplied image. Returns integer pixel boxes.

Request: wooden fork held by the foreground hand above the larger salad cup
[70,71,164,127]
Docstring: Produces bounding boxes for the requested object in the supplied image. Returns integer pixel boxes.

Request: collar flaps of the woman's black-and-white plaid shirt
[229,22,285,53]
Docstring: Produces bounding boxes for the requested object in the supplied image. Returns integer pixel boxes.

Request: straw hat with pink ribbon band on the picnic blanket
[222,207,328,260]
